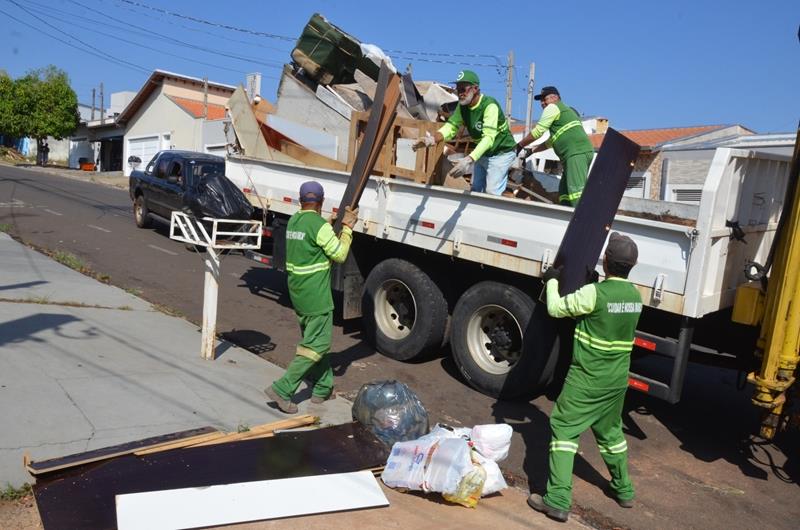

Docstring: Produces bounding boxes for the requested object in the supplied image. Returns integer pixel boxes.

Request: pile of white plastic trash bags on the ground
[381,423,513,508]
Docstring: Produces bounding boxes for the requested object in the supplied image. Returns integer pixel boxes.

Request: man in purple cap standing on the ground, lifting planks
[264,181,358,414]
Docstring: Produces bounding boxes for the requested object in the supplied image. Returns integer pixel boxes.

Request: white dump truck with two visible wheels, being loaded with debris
[219,89,791,403]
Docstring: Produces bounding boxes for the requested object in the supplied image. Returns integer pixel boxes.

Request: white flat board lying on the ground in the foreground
[116,471,389,530]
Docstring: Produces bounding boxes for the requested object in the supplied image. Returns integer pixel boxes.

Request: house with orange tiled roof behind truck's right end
[589,125,754,202]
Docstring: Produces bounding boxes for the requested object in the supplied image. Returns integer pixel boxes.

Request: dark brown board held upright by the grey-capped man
[553,128,640,296]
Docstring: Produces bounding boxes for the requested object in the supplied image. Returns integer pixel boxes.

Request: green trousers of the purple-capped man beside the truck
[272,311,333,399]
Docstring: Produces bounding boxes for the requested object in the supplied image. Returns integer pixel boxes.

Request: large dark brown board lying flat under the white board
[33,423,389,530]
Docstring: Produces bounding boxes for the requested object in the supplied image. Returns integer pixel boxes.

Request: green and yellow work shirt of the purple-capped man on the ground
[286,210,353,316]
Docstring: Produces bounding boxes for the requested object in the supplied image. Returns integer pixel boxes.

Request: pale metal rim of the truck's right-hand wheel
[467,305,522,375]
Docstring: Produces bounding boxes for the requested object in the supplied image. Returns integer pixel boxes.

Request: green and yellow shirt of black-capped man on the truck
[531,101,594,161]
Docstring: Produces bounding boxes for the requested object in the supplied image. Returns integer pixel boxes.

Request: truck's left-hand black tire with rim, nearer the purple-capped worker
[362,258,447,361]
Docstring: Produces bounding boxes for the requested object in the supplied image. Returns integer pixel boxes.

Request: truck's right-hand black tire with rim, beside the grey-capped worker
[450,281,558,399]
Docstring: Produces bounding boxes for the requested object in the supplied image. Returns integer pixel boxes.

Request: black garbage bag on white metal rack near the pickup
[183,174,253,220]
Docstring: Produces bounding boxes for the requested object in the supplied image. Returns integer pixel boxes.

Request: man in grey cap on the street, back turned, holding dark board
[528,232,642,521]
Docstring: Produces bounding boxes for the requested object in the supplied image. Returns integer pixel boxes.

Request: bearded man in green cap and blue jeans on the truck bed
[414,70,516,195]
